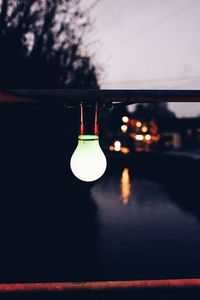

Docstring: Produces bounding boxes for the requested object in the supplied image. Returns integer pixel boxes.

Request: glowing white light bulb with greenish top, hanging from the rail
[70,134,107,182]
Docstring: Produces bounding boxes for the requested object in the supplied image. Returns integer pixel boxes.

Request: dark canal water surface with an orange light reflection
[92,168,200,279]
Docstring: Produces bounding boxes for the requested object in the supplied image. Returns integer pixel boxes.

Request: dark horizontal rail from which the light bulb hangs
[2,89,200,106]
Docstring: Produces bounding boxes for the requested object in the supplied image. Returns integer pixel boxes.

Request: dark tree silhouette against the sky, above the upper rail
[0,0,98,88]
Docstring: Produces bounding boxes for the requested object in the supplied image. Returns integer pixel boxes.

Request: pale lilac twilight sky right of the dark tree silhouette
[82,0,200,116]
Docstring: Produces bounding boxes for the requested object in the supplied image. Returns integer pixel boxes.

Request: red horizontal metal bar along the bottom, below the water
[0,278,200,293]
